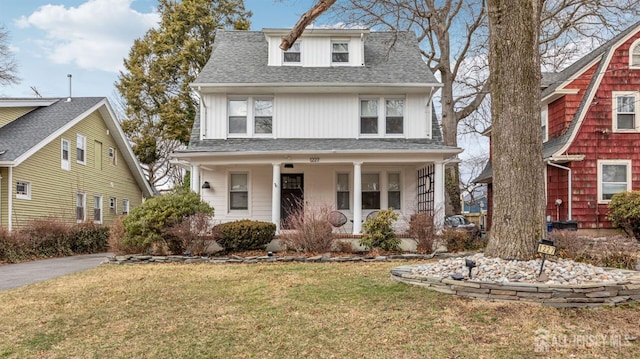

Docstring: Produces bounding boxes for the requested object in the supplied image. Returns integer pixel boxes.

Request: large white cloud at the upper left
[16,0,160,72]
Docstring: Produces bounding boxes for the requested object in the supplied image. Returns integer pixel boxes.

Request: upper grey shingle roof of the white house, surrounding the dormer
[193,30,438,86]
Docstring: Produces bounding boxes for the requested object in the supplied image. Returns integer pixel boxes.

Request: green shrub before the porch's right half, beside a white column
[360,208,400,251]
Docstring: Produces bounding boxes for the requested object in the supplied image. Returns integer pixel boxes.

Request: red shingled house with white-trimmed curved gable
[475,22,640,229]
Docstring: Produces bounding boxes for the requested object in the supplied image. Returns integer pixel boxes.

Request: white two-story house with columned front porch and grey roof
[174,29,461,234]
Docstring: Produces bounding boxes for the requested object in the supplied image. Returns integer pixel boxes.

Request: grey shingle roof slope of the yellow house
[0,97,104,161]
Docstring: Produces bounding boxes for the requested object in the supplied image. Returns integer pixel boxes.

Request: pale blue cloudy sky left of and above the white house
[0,0,322,99]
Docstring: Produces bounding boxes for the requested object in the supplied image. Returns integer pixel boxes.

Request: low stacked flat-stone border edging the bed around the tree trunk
[391,265,640,308]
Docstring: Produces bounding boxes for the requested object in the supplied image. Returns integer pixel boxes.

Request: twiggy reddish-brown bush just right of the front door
[280,206,334,253]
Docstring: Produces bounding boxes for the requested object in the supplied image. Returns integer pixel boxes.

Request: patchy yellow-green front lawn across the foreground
[0,263,640,358]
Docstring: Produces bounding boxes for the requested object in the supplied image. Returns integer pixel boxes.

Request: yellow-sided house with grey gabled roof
[0,97,153,231]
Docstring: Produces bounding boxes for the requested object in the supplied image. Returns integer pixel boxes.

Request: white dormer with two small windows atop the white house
[262,29,369,67]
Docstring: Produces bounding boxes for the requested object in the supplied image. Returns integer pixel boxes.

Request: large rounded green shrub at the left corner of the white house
[121,191,213,249]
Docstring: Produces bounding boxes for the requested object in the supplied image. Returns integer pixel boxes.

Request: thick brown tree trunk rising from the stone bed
[485,0,545,260]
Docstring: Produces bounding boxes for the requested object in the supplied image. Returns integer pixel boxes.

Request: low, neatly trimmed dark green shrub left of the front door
[213,219,276,252]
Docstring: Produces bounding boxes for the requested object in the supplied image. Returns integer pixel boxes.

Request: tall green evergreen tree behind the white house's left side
[116,0,251,188]
